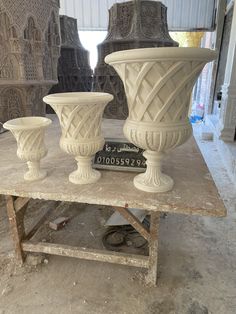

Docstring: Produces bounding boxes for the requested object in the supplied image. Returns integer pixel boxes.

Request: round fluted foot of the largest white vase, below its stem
[134,173,174,193]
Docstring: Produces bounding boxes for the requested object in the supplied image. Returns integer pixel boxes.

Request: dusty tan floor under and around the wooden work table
[0,125,236,314]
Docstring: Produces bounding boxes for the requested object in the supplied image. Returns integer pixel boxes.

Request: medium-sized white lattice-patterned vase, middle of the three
[43,92,113,184]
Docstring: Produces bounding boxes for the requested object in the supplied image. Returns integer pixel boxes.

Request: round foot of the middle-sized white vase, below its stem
[69,168,101,184]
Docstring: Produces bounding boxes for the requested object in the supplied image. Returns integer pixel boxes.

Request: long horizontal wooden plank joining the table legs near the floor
[22,242,148,268]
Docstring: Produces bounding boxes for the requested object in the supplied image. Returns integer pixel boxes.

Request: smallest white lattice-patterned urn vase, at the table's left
[3,117,52,181]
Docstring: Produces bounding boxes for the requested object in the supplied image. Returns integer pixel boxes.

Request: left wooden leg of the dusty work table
[6,195,29,265]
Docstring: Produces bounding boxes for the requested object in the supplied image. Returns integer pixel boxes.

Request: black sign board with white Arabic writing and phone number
[94,139,146,172]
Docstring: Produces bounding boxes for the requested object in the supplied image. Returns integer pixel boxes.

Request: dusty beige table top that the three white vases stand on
[0,115,226,217]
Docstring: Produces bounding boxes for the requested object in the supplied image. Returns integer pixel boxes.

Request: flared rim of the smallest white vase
[3,116,52,130]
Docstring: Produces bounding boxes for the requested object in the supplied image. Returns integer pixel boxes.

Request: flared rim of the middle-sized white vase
[43,92,114,105]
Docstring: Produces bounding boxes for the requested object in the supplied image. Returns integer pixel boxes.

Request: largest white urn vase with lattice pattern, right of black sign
[105,47,217,192]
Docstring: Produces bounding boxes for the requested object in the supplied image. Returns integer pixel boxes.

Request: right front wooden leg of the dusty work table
[146,212,160,287]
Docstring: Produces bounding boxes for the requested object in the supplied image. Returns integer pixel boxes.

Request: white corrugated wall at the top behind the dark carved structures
[60,0,216,31]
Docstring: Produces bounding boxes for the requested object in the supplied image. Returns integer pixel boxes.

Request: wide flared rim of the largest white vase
[105,47,218,64]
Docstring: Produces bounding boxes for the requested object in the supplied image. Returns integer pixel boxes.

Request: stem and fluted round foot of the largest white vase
[134,150,174,193]
